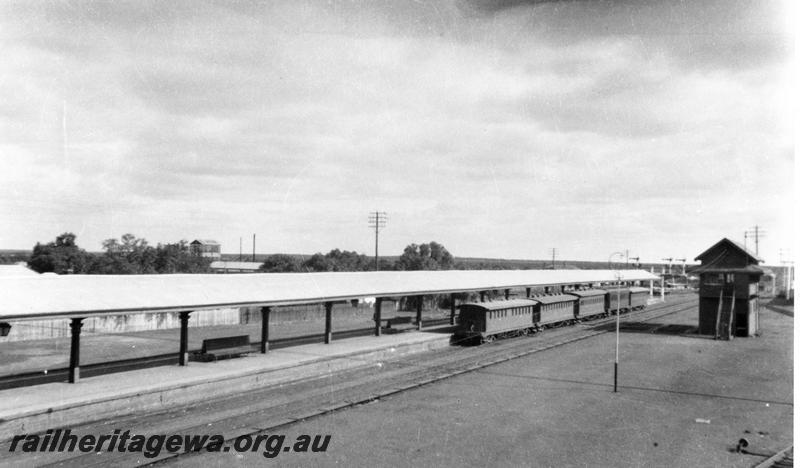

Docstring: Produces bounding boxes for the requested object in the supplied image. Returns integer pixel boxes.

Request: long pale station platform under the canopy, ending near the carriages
[0,326,452,440]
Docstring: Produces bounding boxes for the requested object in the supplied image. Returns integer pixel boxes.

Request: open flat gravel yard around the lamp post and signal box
[190,306,793,467]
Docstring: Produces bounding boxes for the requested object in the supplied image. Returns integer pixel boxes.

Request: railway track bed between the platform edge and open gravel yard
[29,298,696,466]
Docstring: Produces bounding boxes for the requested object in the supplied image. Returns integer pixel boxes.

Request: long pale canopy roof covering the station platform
[0,270,658,319]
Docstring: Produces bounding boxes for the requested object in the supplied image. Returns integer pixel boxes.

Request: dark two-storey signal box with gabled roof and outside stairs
[691,239,764,339]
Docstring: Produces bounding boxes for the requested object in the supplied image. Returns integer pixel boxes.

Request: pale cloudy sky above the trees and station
[0,0,796,264]
